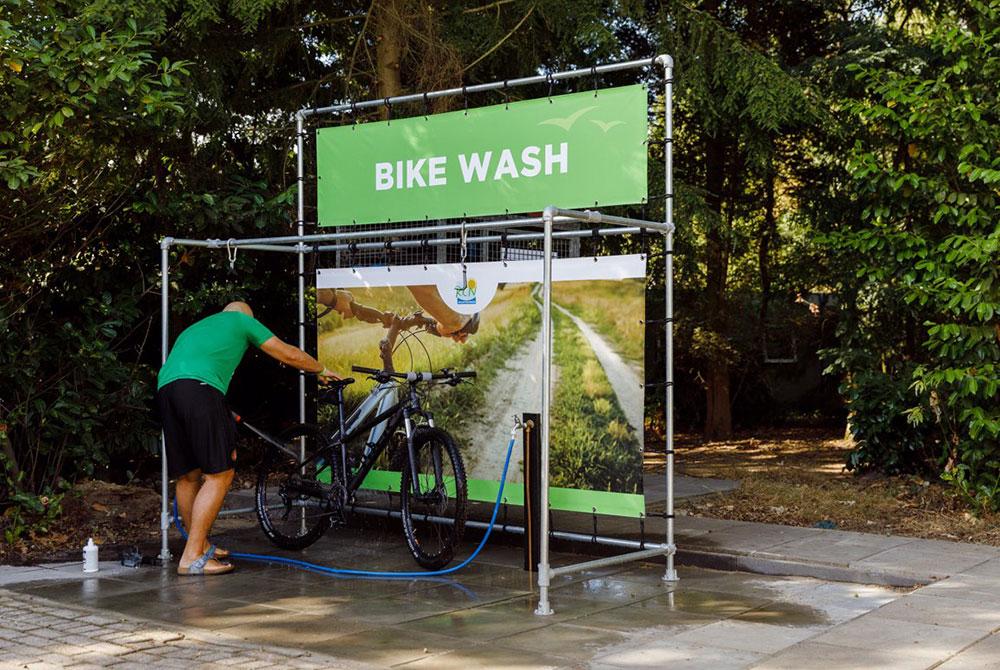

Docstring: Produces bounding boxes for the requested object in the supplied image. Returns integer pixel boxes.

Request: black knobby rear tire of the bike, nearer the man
[254,424,340,550]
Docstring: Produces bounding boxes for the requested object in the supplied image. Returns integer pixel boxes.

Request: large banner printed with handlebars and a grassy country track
[316,255,646,517]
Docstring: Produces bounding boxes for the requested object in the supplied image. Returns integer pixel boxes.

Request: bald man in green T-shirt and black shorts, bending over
[156,302,338,575]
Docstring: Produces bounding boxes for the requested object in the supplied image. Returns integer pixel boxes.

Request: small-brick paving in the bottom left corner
[0,589,366,670]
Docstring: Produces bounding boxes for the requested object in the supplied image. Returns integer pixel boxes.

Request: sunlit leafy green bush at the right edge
[825,0,1000,509]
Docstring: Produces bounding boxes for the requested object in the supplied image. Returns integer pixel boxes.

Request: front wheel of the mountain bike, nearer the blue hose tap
[400,427,469,570]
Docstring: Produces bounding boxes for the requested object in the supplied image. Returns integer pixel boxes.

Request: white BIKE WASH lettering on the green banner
[375,142,569,191]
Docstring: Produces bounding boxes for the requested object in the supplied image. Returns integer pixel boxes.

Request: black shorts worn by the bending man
[156,379,236,479]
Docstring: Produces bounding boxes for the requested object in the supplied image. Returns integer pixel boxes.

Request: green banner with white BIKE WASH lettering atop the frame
[316,85,647,226]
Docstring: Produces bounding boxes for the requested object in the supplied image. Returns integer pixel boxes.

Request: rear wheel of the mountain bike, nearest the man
[256,424,341,549]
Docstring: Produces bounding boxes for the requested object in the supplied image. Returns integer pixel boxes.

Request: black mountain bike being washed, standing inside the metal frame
[250,315,476,570]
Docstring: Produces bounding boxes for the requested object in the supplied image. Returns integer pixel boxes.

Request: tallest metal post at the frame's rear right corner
[656,55,679,582]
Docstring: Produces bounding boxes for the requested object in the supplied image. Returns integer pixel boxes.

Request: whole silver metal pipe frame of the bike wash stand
[160,55,678,616]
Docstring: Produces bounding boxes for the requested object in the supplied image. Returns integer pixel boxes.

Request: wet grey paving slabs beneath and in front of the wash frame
[0,521,912,669]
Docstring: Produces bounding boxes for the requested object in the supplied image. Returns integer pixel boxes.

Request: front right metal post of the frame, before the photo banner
[535,207,555,616]
